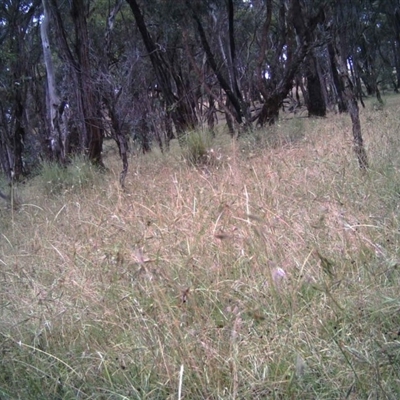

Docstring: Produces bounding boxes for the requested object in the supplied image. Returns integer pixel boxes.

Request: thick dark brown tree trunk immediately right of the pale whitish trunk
[43,0,104,166]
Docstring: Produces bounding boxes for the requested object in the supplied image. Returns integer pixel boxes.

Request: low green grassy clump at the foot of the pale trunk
[39,156,100,194]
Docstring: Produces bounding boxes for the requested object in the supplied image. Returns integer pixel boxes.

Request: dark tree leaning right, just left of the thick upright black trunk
[257,0,324,125]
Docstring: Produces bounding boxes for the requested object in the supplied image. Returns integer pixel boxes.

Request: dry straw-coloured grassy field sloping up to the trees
[0,96,400,400]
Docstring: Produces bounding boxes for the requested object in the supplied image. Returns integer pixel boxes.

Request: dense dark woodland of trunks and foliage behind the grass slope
[0,0,400,185]
